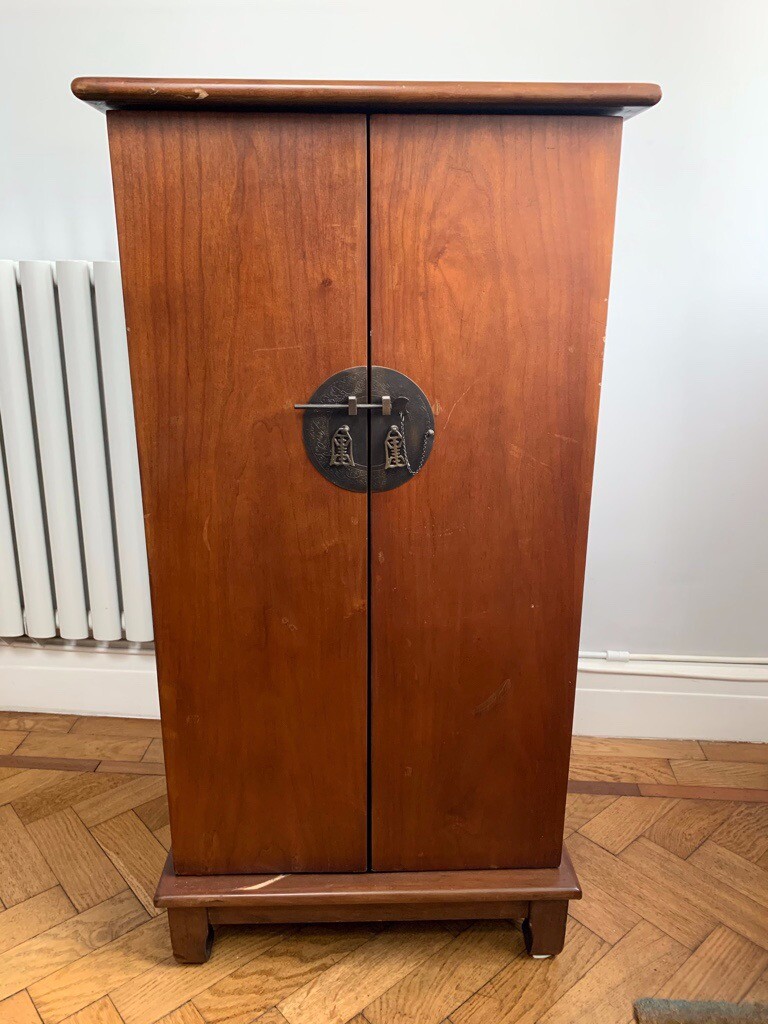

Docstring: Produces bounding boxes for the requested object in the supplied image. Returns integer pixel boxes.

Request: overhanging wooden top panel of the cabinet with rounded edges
[72,78,662,118]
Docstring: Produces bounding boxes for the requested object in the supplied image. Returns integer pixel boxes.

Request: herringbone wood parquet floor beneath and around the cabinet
[0,713,768,1024]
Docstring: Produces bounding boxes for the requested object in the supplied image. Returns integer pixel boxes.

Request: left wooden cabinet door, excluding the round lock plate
[109,112,368,873]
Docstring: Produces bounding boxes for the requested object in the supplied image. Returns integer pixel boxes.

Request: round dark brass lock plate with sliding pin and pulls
[303,367,434,493]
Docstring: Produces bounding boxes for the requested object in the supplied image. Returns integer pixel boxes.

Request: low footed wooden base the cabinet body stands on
[155,847,582,964]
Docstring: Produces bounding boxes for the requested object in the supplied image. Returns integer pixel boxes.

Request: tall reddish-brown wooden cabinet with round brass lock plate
[74,79,659,961]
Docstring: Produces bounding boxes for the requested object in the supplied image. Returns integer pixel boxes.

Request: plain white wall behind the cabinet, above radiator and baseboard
[0,0,768,656]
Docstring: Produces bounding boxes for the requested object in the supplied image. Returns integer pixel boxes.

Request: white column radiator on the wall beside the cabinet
[0,260,153,642]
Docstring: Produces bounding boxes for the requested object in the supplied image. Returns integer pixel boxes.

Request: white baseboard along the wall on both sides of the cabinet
[0,646,768,741]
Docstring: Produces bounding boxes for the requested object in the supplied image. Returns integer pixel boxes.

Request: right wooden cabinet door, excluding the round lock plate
[370,115,622,870]
